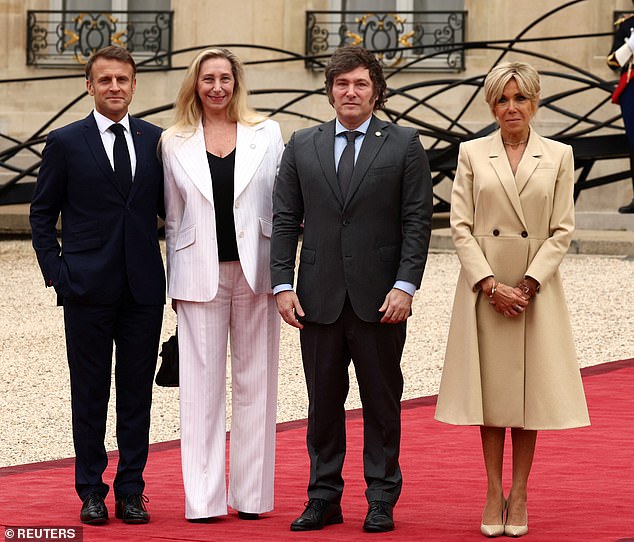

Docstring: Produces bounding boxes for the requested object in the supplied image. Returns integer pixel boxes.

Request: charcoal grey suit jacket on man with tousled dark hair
[271,117,432,324]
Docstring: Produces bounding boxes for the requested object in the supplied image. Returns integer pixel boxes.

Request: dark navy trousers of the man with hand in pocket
[64,292,163,499]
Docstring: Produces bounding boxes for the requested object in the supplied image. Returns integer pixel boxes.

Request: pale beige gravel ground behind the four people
[0,240,634,467]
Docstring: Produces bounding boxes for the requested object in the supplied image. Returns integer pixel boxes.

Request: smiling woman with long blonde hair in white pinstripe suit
[162,48,284,521]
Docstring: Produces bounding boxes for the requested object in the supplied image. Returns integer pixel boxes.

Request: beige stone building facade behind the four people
[0,0,633,211]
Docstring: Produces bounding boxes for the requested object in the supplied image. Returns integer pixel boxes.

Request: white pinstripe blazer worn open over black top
[161,119,284,302]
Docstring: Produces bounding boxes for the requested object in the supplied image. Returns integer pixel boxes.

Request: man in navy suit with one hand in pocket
[30,46,165,524]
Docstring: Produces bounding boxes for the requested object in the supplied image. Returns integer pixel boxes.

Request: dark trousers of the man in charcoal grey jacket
[300,301,407,504]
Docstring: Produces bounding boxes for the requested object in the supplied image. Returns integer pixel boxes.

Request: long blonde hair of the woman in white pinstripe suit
[168,47,266,133]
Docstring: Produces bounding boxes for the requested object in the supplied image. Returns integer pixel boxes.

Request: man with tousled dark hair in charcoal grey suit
[271,47,432,532]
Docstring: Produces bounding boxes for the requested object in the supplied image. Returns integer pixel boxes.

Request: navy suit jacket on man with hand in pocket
[30,113,165,305]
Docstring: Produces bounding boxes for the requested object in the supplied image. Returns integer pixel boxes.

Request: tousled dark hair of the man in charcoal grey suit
[325,45,387,109]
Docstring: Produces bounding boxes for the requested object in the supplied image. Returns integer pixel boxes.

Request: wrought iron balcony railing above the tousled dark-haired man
[306,11,467,72]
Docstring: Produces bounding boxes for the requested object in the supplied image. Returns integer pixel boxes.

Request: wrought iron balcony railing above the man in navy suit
[26,10,173,69]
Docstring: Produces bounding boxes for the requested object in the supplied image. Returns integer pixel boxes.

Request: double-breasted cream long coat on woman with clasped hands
[436,130,590,429]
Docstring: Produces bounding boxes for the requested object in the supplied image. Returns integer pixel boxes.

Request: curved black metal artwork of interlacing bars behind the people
[0,0,631,211]
